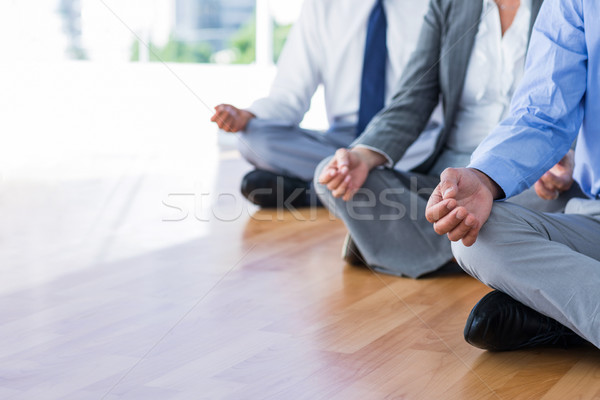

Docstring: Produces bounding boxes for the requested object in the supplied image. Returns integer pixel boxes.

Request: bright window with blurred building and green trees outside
[0,0,302,64]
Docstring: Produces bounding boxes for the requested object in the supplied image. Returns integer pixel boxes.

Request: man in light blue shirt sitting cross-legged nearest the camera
[426,0,600,350]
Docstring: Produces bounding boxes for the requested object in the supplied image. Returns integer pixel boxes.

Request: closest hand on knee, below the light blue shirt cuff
[425,168,502,246]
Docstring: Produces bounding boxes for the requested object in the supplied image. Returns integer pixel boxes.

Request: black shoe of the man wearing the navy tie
[241,169,311,208]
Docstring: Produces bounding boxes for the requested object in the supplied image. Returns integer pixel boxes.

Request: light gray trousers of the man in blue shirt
[452,198,600,347]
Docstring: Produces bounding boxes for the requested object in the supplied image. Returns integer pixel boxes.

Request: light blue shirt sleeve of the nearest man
[469,0,587,197]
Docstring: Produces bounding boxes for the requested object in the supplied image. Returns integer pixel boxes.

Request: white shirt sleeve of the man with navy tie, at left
[246,0,323,124]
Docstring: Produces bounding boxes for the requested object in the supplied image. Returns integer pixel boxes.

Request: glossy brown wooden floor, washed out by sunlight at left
[0,63,600,400]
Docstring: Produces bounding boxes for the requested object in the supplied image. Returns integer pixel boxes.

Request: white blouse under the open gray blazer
[446,0,531,154]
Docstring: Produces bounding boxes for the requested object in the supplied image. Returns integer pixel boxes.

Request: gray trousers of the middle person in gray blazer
[315,151,580,278]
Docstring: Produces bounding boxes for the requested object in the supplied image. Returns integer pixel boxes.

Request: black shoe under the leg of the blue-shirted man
[464,290,587,351]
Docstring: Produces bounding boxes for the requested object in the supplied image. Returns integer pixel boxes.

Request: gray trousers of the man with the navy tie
[237,118,441,182]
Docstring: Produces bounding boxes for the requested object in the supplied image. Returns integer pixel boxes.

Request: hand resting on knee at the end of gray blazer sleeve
[319,147,385,201]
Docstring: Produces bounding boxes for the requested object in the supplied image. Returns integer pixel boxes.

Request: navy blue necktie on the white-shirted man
[356,0,387,136]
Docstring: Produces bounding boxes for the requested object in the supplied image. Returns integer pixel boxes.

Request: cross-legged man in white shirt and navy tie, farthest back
[212,0,439,207]
